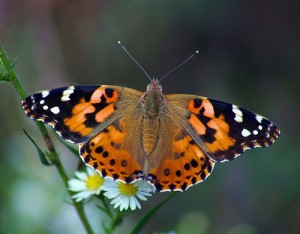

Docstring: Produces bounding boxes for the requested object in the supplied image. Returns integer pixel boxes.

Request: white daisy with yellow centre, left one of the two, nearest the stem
[68,167,106,202]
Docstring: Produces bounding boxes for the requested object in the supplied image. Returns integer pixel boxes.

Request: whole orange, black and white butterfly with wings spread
[22,79,280,192]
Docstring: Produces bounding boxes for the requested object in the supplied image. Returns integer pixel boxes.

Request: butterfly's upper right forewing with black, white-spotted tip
[167,95,280,162]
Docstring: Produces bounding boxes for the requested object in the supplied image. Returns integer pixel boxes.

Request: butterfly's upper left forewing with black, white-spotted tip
[22,85,142,143]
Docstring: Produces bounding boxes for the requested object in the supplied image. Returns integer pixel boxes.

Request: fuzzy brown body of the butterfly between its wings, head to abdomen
[140,80,166,155]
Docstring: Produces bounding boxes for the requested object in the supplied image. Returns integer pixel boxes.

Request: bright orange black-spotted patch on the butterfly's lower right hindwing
[148,136,214,192]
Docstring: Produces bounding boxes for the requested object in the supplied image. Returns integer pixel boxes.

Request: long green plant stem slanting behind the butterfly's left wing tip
[0,46,93,234]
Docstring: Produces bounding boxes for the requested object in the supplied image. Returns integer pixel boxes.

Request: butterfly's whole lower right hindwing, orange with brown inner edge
[147,120,215,192]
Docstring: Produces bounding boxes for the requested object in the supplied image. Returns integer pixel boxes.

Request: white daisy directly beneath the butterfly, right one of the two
[104,180,155,211]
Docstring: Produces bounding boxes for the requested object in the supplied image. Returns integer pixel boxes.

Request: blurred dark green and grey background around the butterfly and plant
[0,0,300,234]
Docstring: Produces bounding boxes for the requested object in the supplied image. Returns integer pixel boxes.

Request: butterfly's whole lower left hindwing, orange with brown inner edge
[80,117,145,183]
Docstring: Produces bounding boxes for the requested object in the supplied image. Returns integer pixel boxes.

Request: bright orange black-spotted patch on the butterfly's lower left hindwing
[80,123,143,183]
